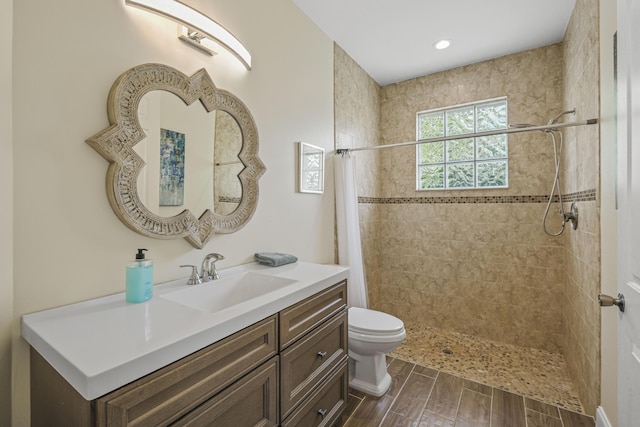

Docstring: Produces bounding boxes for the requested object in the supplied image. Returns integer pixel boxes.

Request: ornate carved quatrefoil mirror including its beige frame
[86,64,265,249]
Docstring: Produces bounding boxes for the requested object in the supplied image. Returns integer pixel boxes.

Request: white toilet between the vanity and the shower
[349,307,407,397]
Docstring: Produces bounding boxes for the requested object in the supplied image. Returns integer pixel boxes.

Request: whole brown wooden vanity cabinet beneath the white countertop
[31,282,348,427]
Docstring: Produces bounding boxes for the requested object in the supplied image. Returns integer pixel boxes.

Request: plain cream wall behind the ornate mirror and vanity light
[11,0,334,426]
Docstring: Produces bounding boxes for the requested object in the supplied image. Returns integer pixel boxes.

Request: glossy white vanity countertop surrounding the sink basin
[22,262,348,400]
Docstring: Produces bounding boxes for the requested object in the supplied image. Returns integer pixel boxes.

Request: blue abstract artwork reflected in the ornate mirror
[160,129,185,206]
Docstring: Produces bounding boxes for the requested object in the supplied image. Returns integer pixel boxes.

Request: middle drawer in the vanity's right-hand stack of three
[280,310,348,418]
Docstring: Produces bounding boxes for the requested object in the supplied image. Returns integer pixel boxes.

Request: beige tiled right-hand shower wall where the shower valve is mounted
[562,0,602,415]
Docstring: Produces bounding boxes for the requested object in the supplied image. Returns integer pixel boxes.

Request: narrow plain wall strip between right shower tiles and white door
[600,0,618,426]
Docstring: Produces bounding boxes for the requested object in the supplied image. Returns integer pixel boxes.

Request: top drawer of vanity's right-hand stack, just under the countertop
[280,280,347,349]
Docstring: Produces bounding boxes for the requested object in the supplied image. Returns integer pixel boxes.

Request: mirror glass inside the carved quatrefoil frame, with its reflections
[133,91,244,217]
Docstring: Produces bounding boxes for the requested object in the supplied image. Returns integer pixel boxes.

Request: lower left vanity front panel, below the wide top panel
[172,357,278,427]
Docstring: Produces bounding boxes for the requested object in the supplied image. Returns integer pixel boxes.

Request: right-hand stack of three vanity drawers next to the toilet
[280,282,348,427]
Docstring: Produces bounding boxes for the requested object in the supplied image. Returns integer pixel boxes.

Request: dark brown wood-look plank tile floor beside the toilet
[337,357,595,427]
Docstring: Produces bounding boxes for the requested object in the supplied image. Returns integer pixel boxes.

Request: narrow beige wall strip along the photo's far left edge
[0,0,13,427]
